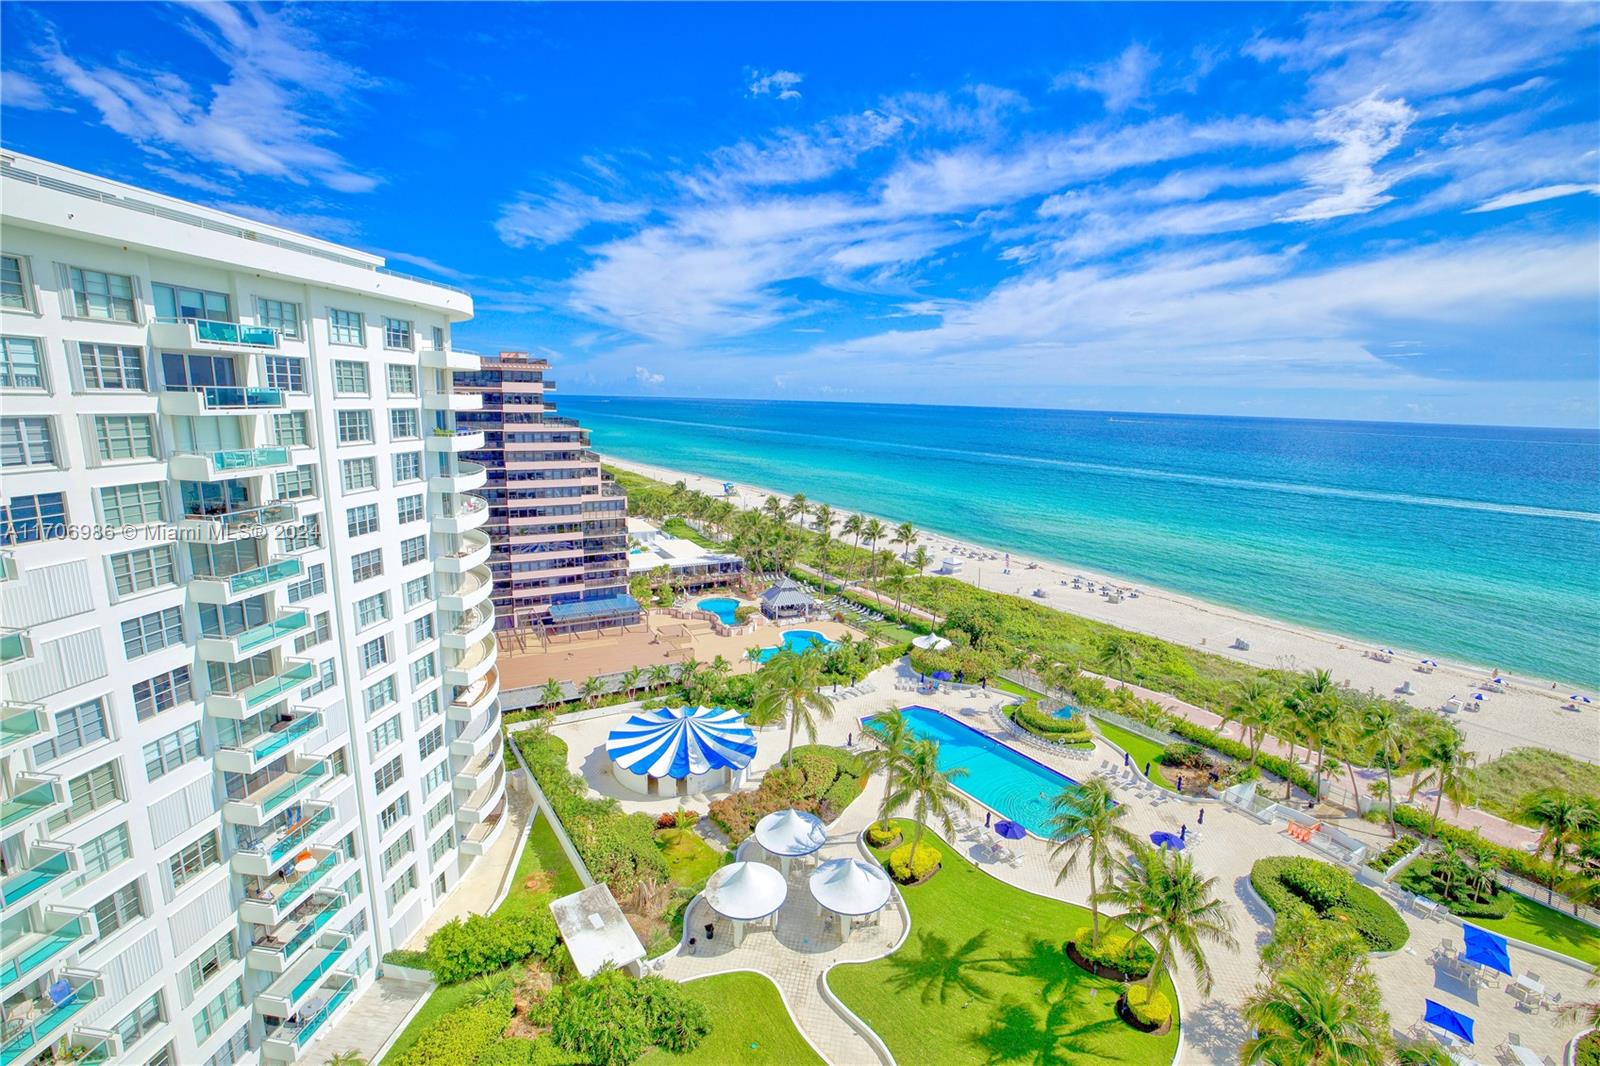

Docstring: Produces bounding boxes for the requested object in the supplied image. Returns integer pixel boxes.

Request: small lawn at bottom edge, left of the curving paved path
[642,973,822,1066]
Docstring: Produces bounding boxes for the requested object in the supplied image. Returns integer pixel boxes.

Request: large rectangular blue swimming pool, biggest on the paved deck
[867,706,1077,837]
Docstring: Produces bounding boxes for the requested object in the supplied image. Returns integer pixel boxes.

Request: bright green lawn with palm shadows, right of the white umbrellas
[827,821,1178,1066]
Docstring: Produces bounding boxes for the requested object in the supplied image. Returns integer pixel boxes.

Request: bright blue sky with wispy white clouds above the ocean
[0,3,1600,426]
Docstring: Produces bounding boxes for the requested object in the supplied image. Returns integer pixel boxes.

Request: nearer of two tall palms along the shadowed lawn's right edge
[1099,844,1237,994]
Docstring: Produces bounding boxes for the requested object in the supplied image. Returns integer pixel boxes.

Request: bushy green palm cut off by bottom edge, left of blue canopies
[1240,970,1384,1066]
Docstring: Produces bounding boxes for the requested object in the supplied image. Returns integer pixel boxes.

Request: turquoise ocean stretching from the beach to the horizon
[560,397,1600,688]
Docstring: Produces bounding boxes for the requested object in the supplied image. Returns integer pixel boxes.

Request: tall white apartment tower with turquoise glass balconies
[0,155,506,1066]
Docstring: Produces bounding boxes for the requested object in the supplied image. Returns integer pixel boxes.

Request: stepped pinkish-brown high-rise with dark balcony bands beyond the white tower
[456,352,640,637]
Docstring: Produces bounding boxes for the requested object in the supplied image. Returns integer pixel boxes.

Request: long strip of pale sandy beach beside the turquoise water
[602,455,1600,762]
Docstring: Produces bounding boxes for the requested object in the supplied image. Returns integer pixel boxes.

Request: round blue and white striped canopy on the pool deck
[605,707,755,778]
